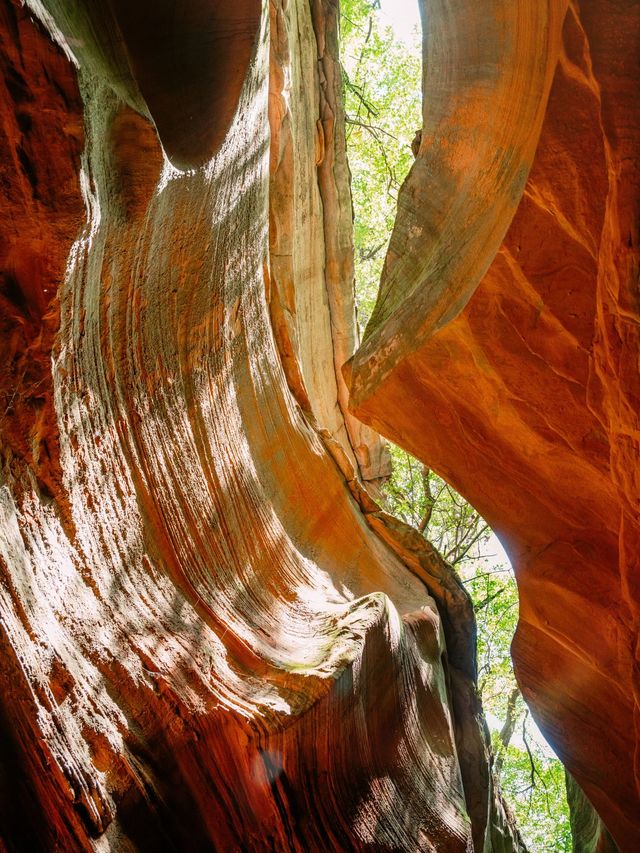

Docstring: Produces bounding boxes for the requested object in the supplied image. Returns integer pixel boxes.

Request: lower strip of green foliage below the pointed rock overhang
[385,446,572,853]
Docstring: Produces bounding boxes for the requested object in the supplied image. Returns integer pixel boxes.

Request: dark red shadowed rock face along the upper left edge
[0,3,84,506]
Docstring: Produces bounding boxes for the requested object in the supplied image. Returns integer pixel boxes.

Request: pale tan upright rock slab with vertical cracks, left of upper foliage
[269,2,391,481]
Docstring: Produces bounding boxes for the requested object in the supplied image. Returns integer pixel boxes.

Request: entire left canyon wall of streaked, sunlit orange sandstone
[0,0,521,853]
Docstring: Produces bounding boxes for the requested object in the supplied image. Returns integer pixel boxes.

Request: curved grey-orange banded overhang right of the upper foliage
[356,0,567,380]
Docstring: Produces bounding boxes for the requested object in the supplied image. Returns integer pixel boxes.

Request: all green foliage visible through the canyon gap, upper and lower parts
[341,0,571,853]
